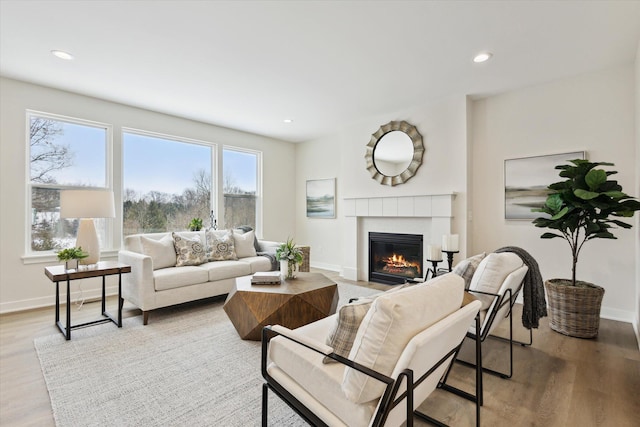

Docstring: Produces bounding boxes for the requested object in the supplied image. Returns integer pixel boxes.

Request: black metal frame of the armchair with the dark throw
[456,283,533,379]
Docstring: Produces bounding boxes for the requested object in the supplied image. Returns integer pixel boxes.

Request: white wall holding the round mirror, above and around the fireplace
[295,97,467,271]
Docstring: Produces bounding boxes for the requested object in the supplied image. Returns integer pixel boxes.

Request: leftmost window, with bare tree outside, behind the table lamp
[27,111,111,253]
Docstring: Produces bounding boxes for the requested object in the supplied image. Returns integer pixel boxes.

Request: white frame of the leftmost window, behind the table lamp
[22,109,117,264]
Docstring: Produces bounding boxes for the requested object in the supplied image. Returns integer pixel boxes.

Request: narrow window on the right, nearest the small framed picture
[222,147,260,230]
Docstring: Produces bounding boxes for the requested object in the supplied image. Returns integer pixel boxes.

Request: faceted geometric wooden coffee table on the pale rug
[224,273,338,341]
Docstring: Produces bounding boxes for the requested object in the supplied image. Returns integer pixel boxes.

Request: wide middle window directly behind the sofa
[122,130,213,236]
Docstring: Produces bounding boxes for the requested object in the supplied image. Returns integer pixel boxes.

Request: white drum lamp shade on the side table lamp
[60,190,116,218]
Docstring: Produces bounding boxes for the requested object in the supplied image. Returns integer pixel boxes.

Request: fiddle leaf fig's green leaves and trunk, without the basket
[532,159,640,286]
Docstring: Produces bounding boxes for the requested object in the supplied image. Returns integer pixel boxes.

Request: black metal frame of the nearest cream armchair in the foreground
[261,315,482,427]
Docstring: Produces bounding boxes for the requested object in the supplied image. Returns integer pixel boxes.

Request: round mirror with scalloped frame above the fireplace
[365,121,424,186]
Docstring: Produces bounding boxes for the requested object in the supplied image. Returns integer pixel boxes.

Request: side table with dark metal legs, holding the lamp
[44,261,131,340]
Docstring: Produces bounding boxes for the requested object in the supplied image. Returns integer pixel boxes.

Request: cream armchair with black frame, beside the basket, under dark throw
[458,252,532,378]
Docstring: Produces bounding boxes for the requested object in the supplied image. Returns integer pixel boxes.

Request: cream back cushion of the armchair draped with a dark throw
[469,252,524,310]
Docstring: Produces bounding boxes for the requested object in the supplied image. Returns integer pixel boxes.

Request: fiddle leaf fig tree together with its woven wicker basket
[533,159,640,338]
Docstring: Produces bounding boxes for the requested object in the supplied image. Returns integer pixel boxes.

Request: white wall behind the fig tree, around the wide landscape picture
[471,65,639,322]
